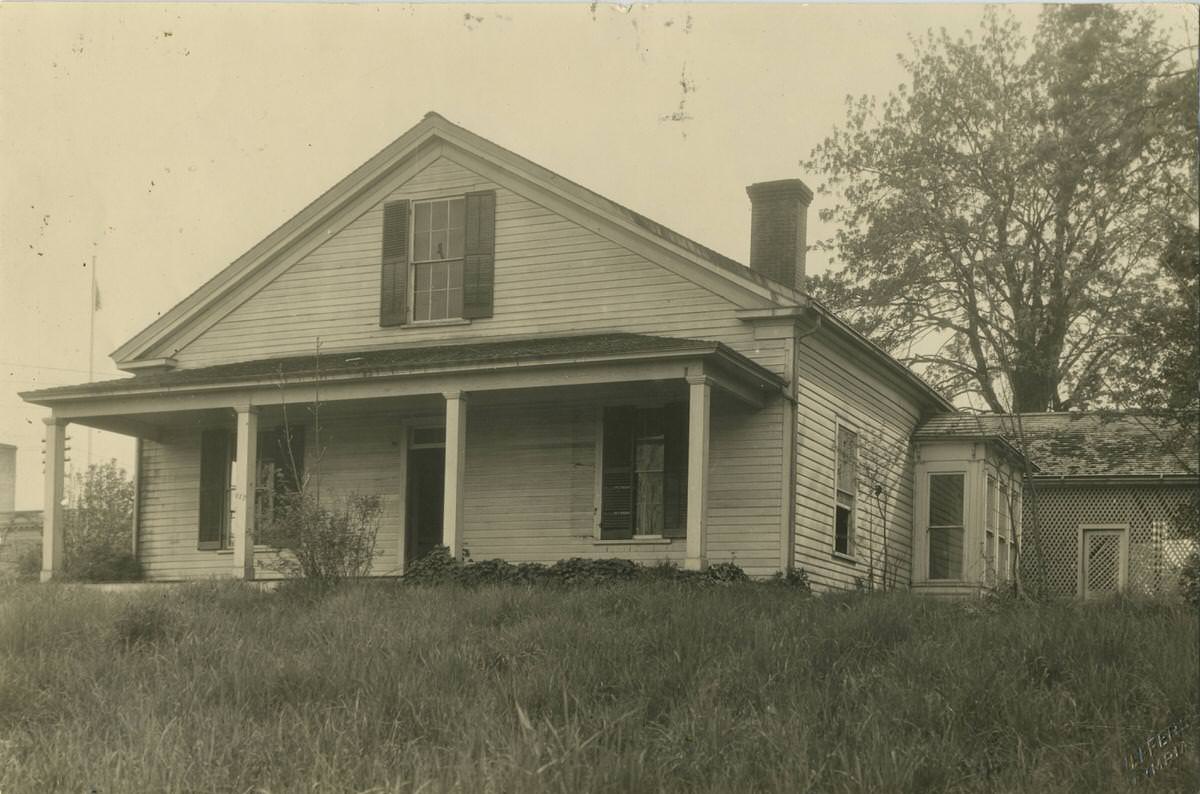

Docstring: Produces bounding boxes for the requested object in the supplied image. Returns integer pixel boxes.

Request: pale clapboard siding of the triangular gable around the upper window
[169,157,768,379]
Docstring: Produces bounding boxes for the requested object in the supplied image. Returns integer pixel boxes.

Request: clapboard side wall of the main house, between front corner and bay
[794,333,920,589]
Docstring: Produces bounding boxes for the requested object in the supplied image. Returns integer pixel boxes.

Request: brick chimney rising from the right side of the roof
[746,179,812,290]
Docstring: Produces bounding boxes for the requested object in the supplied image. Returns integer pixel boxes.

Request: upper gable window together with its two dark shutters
[379,191,496,325]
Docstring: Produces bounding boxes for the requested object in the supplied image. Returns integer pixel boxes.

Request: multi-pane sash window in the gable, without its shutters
[413,198,466,321]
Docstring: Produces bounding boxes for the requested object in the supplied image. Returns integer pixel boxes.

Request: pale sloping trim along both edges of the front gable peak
[112,112,808,366]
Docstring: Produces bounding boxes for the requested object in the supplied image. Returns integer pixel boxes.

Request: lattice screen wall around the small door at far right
[1020,483,1198,596]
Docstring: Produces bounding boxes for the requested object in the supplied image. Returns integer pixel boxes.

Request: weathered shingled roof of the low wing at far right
[913,411,1200,477]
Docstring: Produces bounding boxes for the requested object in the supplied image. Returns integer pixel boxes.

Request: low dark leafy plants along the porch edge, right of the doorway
[402,546,758,587]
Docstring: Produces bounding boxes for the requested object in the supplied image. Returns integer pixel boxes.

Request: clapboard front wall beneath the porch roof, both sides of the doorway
[139,390,782,581]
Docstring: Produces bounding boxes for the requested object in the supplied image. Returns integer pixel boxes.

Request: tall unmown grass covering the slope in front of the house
[0,583,1200,794]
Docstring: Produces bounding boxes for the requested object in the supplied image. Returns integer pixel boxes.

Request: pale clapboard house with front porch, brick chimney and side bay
[23,113,1027,594]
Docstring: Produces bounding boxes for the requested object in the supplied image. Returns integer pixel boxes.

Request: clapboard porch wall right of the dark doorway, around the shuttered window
[463,402,782,576]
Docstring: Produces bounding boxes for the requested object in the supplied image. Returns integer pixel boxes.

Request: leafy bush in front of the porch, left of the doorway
[254,487,383,584]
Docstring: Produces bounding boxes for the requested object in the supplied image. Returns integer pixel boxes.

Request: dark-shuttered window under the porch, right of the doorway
[600,403,688,540]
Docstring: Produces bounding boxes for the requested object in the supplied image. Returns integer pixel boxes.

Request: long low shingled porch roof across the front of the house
[20,333,786,407]
